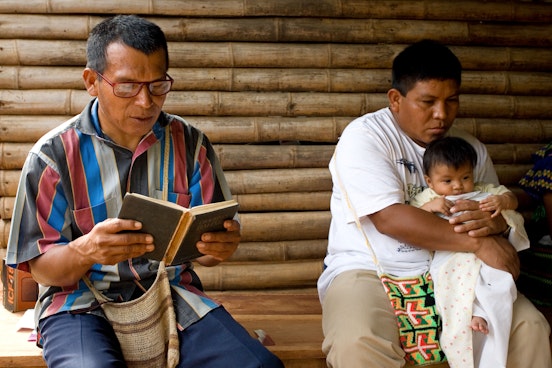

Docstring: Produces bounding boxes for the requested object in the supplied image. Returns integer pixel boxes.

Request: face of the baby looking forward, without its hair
[426,163,474,195]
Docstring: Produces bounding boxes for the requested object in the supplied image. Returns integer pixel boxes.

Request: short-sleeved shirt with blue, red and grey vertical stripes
[7,100,231,340]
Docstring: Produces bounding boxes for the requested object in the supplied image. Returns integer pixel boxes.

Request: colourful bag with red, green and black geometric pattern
[379,272,447,366]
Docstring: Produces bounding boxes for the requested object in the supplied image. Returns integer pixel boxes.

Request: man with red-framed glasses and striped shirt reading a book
[7,16,283,368]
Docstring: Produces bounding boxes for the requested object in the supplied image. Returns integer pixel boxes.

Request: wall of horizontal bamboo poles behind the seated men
[0,0,552,290]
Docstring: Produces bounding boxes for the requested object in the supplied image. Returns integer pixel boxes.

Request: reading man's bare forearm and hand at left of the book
[29,219,154,286]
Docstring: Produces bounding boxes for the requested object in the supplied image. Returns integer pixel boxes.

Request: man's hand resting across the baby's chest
[449,200,508,237]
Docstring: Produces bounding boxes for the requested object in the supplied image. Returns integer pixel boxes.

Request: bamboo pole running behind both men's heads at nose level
[4,90,552,119]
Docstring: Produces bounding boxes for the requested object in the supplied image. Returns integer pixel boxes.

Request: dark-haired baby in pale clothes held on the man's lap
[410,137,528,367]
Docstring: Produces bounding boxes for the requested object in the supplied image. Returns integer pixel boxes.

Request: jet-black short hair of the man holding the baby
[391,39,462,96]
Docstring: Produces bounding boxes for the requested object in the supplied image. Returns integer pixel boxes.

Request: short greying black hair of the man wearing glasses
[86,15,169,73]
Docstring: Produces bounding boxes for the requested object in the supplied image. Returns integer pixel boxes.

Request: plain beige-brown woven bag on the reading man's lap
[84,262,180,368]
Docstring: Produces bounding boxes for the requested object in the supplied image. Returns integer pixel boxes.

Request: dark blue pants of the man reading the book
[40,307,283,368]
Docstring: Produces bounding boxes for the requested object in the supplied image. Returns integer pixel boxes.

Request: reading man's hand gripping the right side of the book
[196,220,241,267]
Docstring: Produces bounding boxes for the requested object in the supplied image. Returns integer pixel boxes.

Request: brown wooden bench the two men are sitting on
[0,289,326,368]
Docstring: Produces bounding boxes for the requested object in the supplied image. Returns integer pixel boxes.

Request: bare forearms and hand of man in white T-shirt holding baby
[370,201,519,278]
